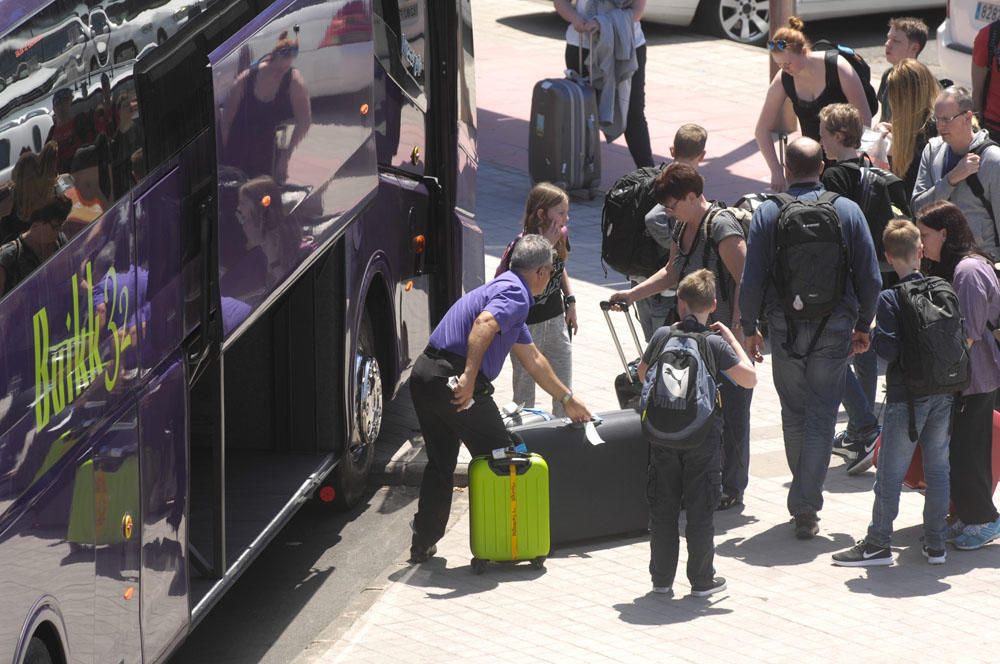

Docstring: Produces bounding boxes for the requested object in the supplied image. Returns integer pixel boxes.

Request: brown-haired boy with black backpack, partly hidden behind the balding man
[819,104,909,475]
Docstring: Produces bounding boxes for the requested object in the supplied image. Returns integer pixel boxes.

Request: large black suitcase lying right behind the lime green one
[511,410,649,546]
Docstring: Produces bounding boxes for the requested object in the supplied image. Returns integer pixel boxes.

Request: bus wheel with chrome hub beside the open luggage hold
[334,312,383,509]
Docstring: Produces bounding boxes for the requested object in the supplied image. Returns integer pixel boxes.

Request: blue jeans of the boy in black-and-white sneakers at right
[865,394,952,549]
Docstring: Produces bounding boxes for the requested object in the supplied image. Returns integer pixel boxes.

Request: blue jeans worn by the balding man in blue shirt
[768,313,854,516]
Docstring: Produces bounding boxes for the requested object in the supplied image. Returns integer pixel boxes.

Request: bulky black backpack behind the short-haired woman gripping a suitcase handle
[601,166,669,277]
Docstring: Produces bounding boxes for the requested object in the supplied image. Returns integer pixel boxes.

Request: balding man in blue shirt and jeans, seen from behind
[740,138,882,539]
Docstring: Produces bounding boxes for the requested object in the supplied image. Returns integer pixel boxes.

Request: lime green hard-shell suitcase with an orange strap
[469,454,549,574]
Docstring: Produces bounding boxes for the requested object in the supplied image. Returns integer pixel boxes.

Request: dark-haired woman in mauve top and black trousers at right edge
[916,201,1000,550]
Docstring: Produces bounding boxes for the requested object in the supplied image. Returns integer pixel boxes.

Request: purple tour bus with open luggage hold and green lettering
[0,0,483,664]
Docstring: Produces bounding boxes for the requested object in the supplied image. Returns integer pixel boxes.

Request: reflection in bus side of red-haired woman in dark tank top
[222,30,312,182]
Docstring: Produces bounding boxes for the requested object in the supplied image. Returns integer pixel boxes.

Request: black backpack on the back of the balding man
[771,191,850,359]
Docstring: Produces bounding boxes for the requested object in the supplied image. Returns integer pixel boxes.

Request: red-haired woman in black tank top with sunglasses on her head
[754,16,872,192]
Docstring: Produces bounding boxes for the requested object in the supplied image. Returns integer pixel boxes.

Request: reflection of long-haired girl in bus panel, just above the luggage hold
[236,176,302,288]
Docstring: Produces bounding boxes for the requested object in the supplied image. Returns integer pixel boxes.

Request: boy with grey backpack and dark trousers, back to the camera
[639,269,757,597]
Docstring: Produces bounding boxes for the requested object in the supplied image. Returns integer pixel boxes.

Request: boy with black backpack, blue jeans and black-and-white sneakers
[833,219,969,567]
